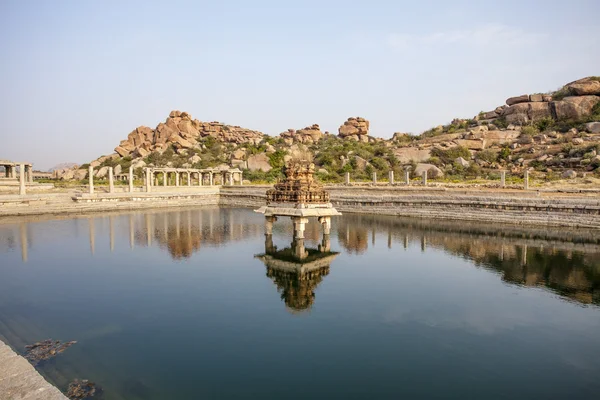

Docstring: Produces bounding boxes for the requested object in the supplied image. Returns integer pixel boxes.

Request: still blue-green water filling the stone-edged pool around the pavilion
[0,208,600,400]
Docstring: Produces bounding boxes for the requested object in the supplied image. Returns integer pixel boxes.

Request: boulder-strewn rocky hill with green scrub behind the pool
[57,77,600,182]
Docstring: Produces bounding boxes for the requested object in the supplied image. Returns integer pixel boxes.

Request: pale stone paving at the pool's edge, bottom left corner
[0,341,67,400]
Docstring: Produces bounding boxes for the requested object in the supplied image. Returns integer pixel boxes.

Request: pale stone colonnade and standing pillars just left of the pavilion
[88,166,243,194]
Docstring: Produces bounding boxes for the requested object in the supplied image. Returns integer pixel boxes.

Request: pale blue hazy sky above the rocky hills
[0,0,600,170]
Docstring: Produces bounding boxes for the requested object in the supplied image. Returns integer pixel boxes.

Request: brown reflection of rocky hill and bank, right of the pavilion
[336,215,600,304]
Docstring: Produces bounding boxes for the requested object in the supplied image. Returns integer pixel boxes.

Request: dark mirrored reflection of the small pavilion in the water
[255,235,339,312]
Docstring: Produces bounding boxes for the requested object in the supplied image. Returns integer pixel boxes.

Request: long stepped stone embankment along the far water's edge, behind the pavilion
[0,185,600,229]
